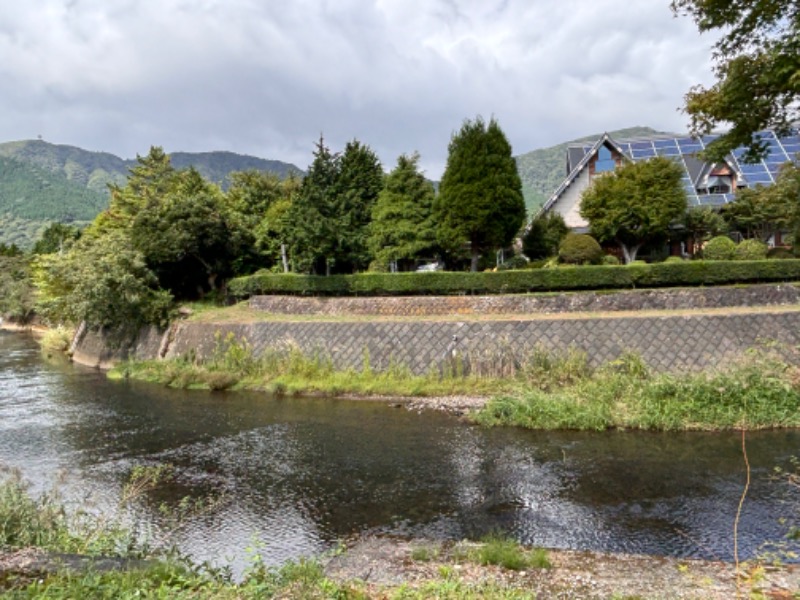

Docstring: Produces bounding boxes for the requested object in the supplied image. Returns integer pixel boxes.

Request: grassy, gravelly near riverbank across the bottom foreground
[0,537,800,600]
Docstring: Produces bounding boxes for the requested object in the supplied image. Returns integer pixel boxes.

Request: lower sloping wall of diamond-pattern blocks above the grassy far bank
[167,311,800,374]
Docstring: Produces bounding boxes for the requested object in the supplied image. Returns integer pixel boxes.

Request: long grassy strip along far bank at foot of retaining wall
[109,334,800,431]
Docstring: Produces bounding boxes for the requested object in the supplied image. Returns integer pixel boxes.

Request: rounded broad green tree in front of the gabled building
[580,156,686,264]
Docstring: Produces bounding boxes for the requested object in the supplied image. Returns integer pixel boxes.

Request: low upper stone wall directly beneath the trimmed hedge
[250,284,800,317]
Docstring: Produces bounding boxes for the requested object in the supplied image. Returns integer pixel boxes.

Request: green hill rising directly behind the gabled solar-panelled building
[517,127,662,216]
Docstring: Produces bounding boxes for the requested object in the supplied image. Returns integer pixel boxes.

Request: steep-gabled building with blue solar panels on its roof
[541,130,800,231]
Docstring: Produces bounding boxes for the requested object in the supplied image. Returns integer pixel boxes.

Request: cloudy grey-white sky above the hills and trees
[0,0,714,178]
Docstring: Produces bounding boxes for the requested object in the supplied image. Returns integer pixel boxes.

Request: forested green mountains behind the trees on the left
[0,140,303,248]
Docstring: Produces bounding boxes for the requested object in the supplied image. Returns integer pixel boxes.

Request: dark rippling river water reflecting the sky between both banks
[0,332,800,570]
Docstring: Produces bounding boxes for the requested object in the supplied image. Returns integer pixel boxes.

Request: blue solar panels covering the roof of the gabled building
[583,130,800,206]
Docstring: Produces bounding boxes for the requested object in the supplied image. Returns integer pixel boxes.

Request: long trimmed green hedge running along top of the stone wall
[228,259,800,299]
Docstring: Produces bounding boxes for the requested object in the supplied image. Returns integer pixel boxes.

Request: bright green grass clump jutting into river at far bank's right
[474,351,800,431]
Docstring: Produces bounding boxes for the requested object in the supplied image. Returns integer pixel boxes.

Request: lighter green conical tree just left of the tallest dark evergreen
[368,153,436,266]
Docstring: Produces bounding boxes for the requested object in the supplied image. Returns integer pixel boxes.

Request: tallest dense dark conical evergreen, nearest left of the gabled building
[434,117,525,271]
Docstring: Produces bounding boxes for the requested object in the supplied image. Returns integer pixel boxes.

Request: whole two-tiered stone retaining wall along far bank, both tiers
[74,285,800,374]
